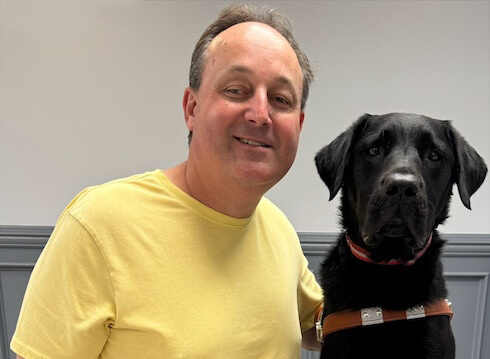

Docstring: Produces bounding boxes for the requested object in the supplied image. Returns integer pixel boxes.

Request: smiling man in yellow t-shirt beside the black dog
[11,5,322,359]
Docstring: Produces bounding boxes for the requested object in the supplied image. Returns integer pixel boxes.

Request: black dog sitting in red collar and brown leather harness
[315,113,487,359]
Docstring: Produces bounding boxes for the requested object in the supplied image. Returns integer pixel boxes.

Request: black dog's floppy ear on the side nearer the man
[315,114,371,201]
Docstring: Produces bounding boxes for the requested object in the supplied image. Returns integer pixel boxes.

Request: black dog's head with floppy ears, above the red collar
[315,113,487,260]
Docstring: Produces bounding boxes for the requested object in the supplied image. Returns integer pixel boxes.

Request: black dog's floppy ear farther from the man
[446,121,487,209]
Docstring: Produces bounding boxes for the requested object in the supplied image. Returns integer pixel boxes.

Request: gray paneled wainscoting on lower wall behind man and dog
[0,226,490,359]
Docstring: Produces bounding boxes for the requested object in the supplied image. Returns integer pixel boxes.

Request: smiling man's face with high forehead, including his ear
[184,22,304,190]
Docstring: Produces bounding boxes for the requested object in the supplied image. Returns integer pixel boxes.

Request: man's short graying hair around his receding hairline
[189,4,314,142]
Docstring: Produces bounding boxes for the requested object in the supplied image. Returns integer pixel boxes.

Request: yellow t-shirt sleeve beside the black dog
[298,255,323,333]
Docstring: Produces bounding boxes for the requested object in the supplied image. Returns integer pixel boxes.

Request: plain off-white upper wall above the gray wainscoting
[0,0,490,233]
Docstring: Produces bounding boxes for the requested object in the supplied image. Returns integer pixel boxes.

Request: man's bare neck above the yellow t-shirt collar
[163,162,264,218]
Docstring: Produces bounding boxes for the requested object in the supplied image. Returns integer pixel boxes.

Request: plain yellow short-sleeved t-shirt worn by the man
[11,170,322,359]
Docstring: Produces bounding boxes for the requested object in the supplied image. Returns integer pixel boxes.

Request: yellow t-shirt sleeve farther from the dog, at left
[11,212,116,359]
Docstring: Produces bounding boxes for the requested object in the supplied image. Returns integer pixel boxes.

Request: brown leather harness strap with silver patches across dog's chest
[316,299,453,342]
